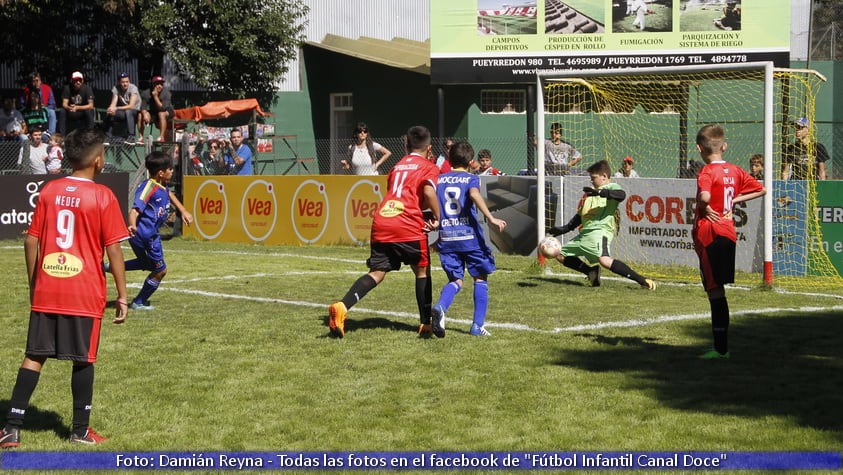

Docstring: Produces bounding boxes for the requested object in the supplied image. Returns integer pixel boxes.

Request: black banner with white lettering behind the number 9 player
[0,173,129,239]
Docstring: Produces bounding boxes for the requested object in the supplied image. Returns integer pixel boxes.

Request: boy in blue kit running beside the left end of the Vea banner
[110,151,193,310]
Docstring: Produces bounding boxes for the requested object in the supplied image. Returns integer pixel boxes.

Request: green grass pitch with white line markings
[0,239,843,473]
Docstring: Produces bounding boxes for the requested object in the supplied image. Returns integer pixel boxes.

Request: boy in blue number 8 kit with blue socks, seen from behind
[430,142,506,338]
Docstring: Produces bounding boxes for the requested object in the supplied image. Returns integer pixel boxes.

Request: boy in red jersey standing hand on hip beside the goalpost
[691,125,767,360]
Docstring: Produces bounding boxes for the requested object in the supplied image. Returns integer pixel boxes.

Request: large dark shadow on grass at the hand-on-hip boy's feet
[557,312,843,437]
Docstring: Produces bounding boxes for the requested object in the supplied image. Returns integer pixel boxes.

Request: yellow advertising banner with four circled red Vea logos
[183,175,386,244]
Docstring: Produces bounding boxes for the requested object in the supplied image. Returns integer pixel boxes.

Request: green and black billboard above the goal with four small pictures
[430,0,790,84]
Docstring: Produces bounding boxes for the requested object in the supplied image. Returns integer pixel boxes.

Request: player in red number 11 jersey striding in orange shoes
[328,126,439,338]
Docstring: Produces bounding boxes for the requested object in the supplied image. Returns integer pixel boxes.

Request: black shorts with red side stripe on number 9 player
[26,312,102,363]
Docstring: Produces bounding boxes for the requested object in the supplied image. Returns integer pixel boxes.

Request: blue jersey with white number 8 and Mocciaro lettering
[436,171,488,253]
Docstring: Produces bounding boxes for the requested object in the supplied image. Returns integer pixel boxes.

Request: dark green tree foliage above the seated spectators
[0,0,308,104]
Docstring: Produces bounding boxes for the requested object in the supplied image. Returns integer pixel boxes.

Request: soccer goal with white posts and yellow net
[536,63,843,285]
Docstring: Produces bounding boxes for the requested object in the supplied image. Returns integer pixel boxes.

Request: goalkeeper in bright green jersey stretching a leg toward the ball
[550,160,656,290]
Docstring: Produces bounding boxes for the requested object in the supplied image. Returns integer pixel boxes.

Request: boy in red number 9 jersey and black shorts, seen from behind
[0,129,128,448]
